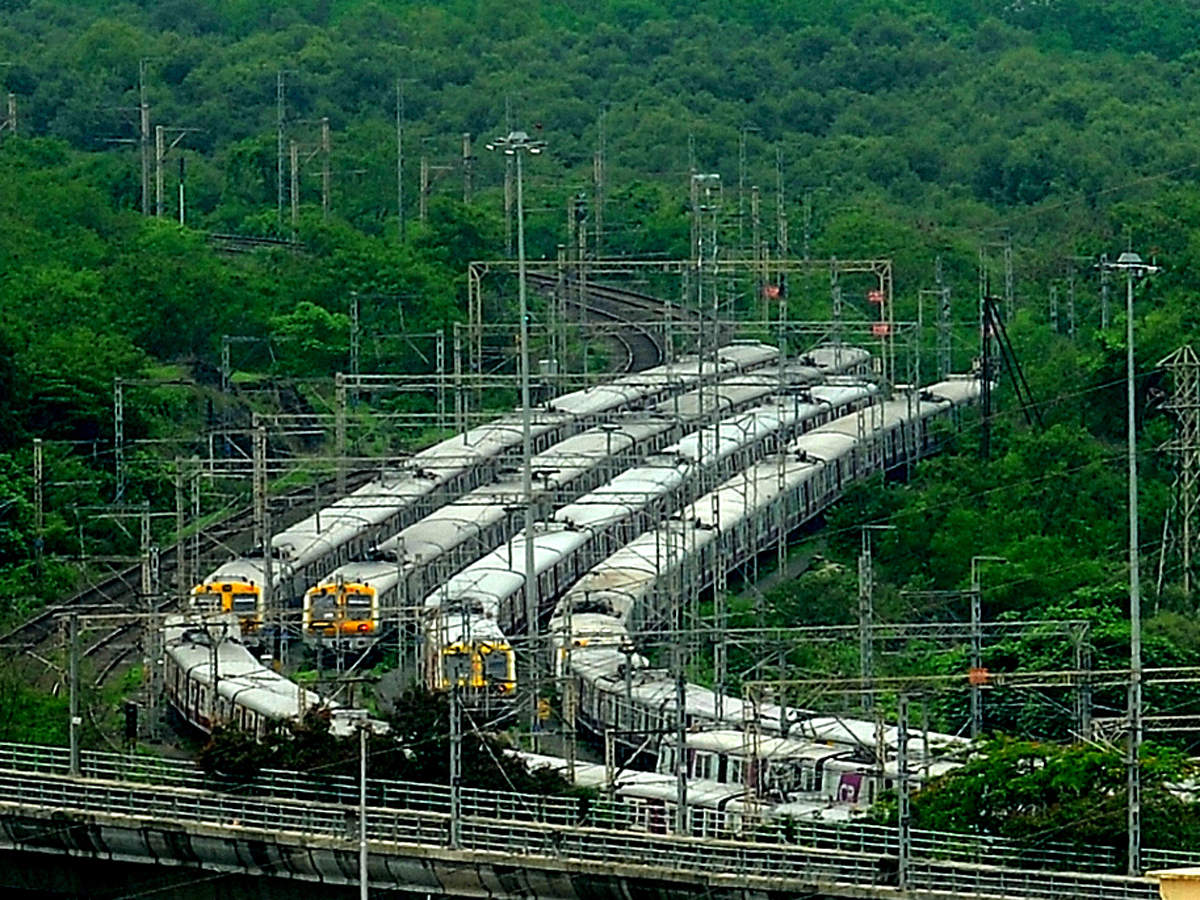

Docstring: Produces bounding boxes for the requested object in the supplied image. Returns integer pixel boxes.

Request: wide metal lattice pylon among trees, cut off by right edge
[1158,346,1200,607]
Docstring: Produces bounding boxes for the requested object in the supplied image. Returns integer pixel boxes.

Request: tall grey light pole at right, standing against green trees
[1100,251,1158,875]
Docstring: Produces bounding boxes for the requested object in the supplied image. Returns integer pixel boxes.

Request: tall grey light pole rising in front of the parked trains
[486,131,546,739]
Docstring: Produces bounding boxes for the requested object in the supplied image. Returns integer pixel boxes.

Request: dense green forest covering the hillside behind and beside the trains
[0,0,1200,859]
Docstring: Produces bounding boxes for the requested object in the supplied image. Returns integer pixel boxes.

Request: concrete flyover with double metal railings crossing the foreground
[0,744,1158,900]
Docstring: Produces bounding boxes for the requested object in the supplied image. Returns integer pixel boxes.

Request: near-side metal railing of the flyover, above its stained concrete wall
[0,770,1157,900]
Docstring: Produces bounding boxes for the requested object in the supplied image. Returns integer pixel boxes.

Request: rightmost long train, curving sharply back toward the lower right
[548,377,979,801]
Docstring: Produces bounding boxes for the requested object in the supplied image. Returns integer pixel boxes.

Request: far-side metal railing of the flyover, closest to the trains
[0,743,1142,872]
